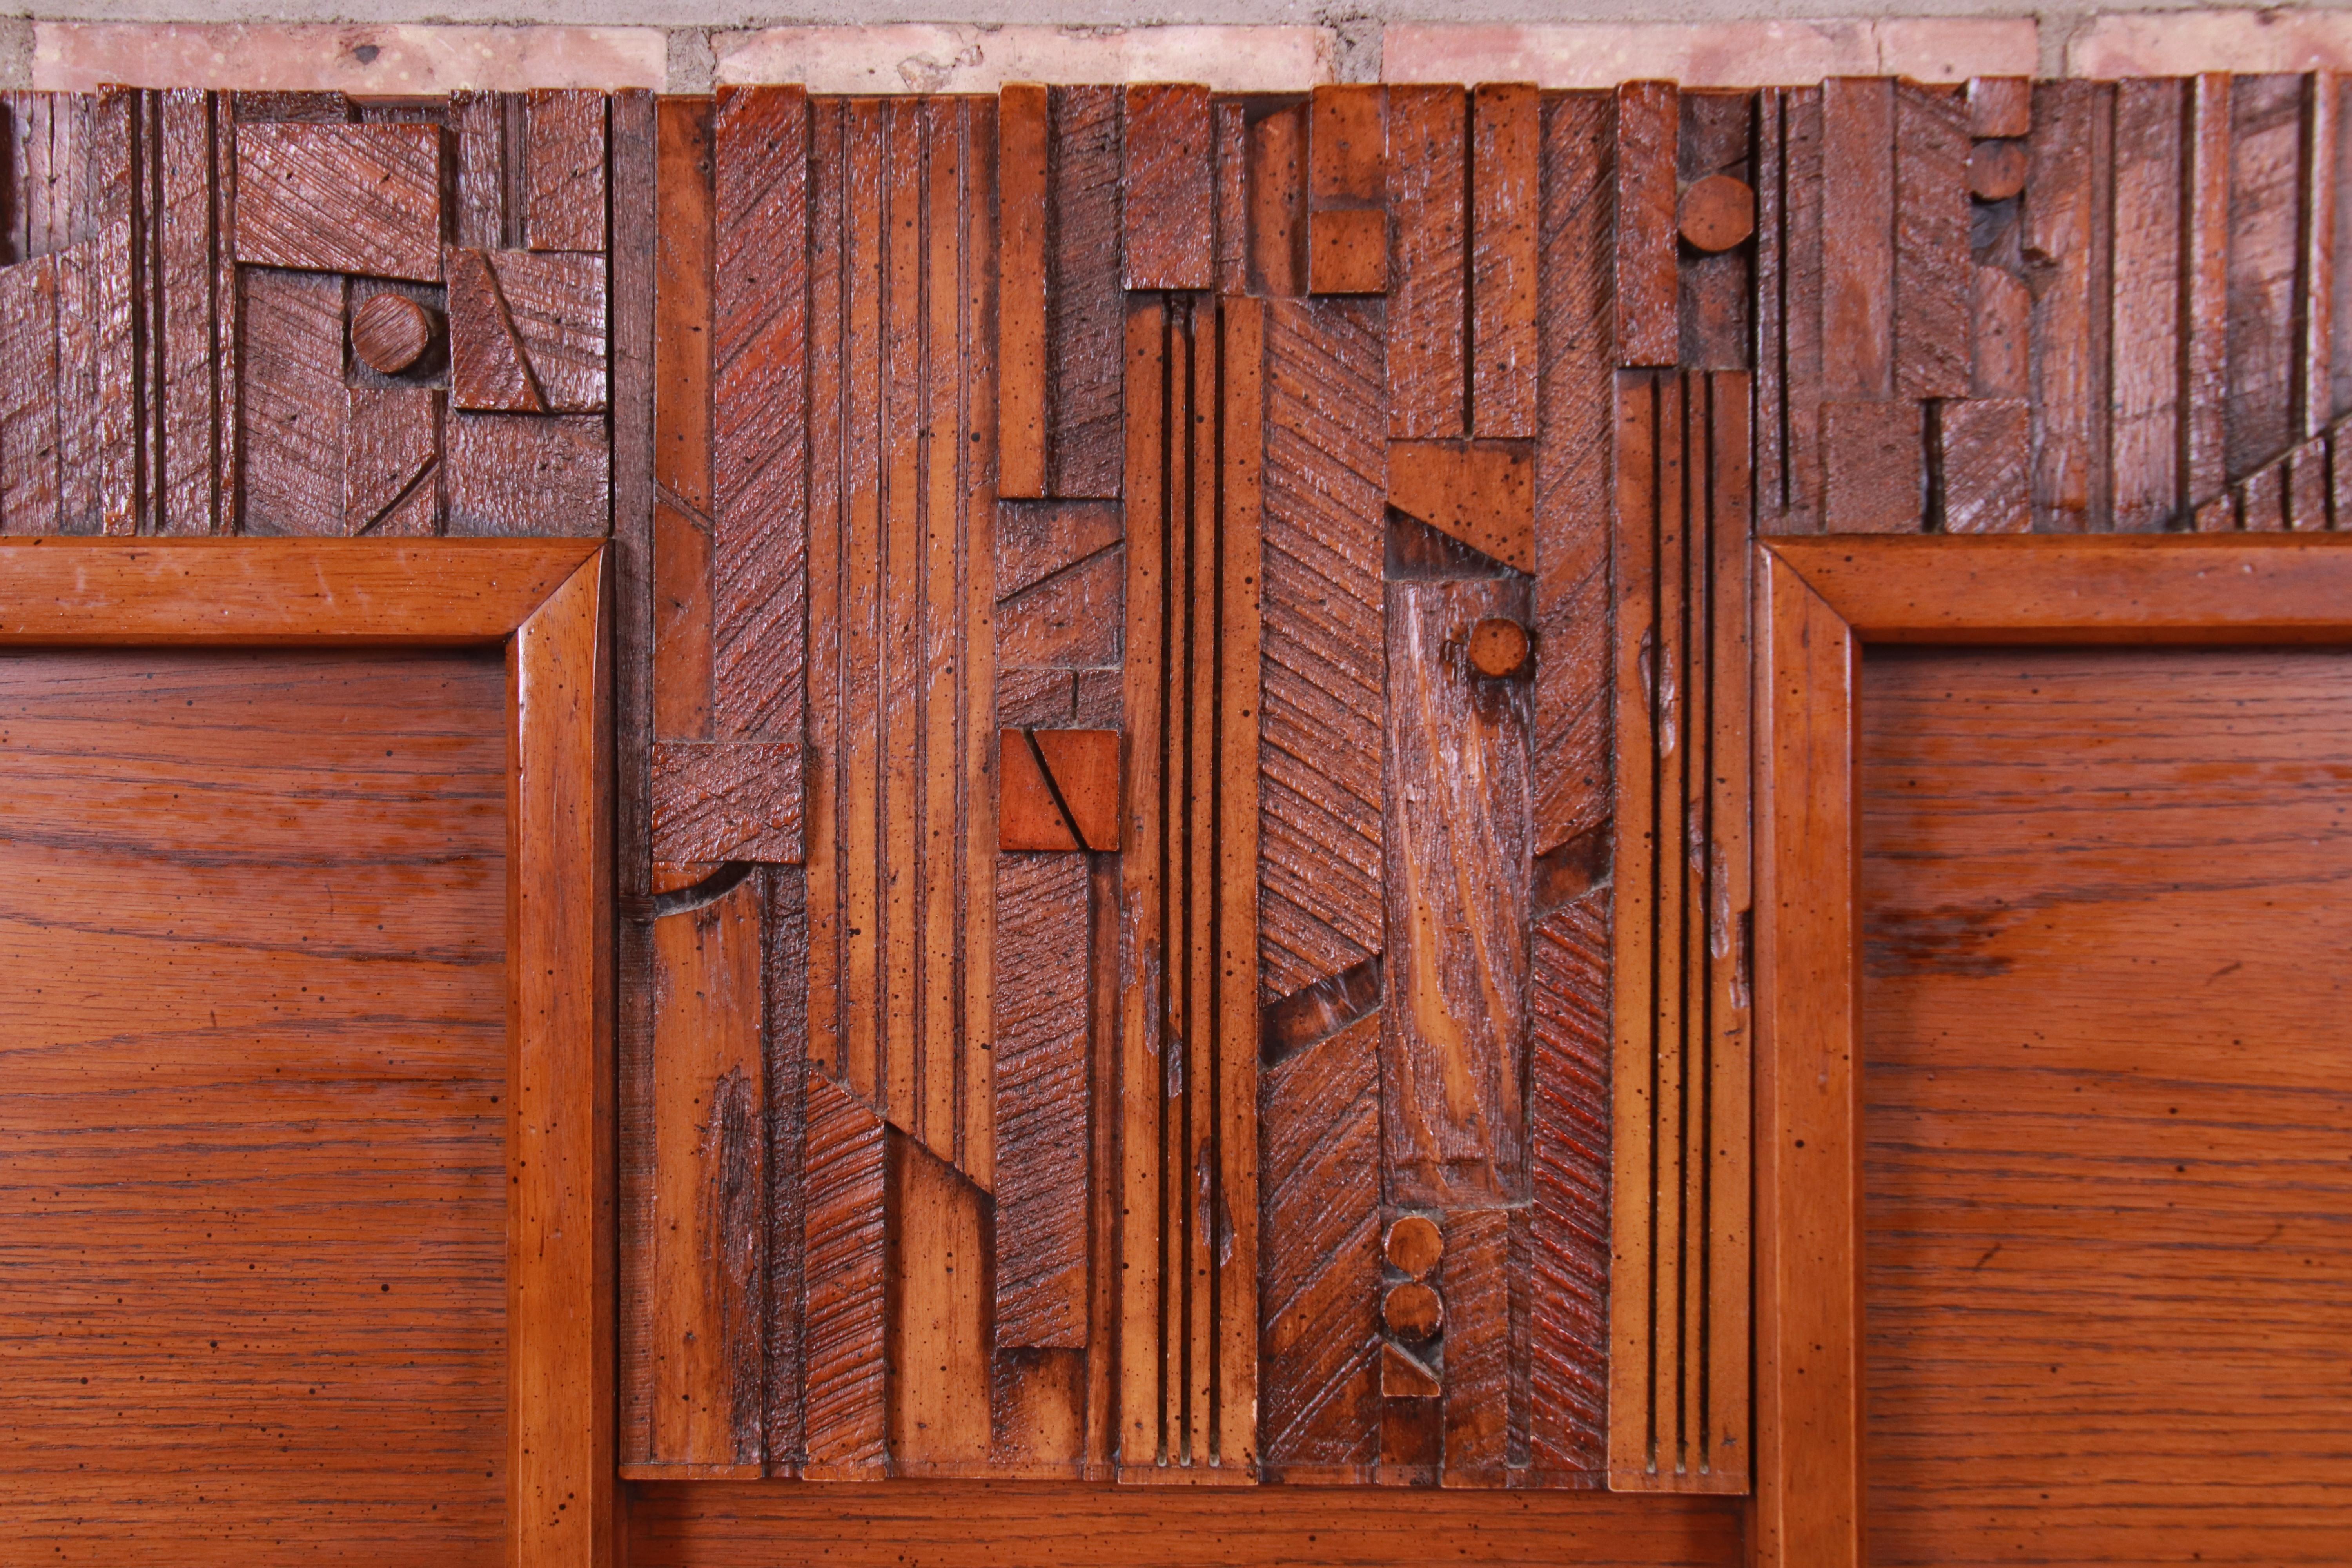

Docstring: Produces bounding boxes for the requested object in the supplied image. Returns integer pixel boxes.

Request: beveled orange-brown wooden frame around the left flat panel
[0,538,619,1568]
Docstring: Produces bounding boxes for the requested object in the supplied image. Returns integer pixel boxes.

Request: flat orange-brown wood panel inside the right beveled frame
[1858,649,2352,1568]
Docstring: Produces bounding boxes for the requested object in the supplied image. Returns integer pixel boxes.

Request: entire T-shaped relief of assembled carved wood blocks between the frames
[0,58,2352,1561]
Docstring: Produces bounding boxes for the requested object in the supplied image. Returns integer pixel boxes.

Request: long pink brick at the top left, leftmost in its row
[33,21,666,94]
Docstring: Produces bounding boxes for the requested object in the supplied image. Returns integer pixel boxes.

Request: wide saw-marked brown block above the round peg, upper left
[235,125,442,282]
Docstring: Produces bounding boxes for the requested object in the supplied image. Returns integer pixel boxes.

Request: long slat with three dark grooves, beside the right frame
[1609,372,1752,1493]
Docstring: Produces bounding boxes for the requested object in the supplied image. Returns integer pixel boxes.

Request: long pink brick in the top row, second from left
[713,24,1331,92]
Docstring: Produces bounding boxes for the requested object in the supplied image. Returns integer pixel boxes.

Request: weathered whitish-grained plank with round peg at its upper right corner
[1381,581,1531,1210]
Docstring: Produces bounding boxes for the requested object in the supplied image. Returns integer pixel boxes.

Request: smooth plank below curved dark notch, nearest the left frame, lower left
[647,879,767,1479]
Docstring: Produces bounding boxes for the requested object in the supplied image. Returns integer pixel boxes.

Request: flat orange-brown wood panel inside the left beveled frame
[0,649,508,1566]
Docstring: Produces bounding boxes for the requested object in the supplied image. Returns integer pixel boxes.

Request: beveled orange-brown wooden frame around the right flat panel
[1750,534,2352,1568]
